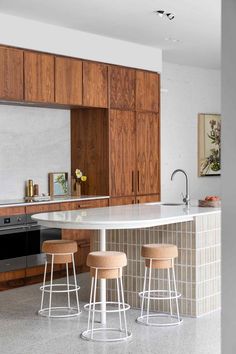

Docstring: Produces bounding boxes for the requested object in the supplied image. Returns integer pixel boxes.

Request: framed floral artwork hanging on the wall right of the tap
[198,113,221,176]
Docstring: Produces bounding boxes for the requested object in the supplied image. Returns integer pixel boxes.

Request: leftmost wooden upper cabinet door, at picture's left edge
[0,47,23,101]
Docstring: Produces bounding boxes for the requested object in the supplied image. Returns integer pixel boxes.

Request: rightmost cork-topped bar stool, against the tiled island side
[136,244,182,326]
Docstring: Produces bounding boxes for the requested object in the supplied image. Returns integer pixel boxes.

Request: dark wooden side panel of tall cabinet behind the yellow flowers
[71,108,109,195]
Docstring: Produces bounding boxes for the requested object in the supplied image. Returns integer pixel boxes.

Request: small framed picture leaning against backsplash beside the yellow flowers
[48,172,68,197]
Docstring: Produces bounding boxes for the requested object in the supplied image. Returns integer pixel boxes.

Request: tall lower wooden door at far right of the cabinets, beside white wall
[136,112,160,195]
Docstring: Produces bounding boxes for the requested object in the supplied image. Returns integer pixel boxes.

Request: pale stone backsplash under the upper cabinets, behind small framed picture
[0,105,71,199]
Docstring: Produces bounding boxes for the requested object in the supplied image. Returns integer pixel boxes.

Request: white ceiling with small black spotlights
[0,0,221,69]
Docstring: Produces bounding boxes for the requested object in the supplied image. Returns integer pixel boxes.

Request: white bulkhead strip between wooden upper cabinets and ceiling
[0,12,162,72]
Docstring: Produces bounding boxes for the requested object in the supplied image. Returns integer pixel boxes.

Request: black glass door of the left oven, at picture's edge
[0,227,27,272]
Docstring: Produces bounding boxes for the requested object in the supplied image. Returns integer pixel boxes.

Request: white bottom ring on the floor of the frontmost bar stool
[81,328,132,342]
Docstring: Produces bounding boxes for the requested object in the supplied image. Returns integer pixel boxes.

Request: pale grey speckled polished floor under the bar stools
[0,274,220,354]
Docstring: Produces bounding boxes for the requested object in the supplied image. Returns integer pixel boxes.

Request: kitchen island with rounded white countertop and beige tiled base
[33,203,221,322]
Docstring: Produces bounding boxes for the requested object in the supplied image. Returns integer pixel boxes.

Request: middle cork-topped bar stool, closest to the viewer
[81,251,131,342]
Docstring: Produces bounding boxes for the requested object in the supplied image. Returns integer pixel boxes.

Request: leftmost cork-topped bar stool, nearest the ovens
[38,240,81,317]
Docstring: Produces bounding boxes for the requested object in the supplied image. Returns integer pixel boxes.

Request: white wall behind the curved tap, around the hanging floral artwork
[161,63,221,201]
